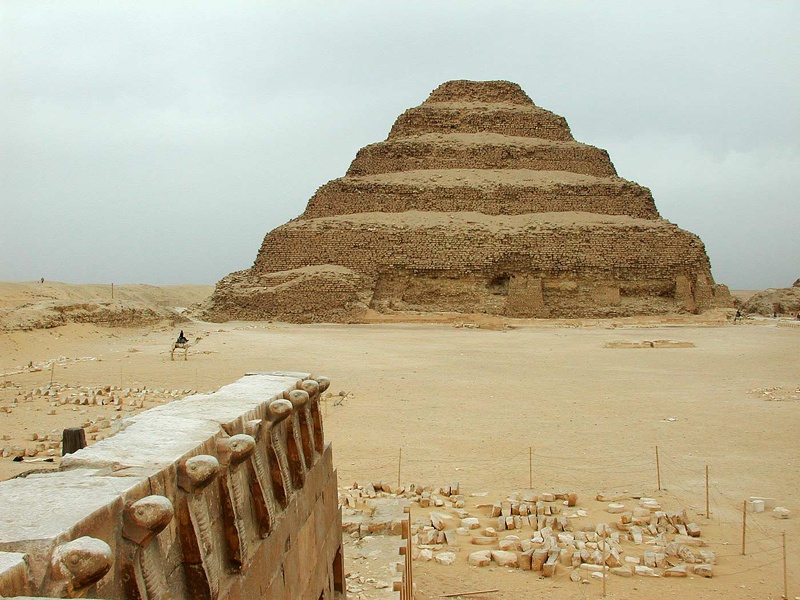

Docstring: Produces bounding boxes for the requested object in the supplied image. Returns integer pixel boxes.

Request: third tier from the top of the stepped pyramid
[347,133,617,177]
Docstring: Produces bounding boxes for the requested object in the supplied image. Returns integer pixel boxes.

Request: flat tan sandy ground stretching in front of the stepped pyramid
[0,288,800,600]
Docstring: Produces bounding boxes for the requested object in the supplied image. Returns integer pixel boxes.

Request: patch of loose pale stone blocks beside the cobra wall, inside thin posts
[339,482,720,581]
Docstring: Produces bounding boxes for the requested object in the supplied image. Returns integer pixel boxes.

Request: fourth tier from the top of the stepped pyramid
[303,169,659,219]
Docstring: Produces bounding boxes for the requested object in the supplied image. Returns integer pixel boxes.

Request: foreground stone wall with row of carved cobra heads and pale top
[0,372,345,600]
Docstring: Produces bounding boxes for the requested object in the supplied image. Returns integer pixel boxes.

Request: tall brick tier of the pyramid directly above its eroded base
[252,211,710,280]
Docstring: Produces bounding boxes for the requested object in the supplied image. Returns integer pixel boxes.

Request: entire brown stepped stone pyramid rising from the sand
[203,81,730,322]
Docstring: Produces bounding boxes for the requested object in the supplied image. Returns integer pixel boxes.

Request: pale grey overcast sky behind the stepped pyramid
[0,0,800,289]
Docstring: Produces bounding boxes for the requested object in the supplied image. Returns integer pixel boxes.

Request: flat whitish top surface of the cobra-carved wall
[0,373,308,550]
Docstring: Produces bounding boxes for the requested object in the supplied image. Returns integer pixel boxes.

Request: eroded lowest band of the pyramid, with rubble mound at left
[202,270,732,323]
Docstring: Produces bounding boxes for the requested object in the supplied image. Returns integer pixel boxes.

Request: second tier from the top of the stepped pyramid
[389,102,574,142]
